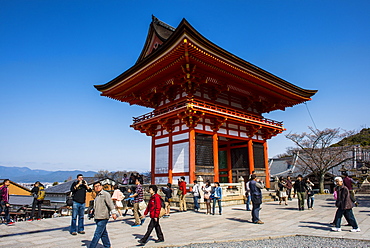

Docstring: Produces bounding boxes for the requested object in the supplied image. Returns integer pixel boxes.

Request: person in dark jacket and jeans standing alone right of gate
[249,174,265,224]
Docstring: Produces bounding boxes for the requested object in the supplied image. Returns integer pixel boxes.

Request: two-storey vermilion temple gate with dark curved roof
[95,17,316,187]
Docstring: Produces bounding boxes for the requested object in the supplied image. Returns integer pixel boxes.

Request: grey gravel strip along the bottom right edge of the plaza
[173,236,370,248]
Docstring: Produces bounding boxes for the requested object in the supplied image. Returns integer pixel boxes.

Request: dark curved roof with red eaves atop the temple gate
[95,17,317,109]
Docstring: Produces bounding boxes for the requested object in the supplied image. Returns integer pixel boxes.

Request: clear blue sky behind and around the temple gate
[0,0,370,171]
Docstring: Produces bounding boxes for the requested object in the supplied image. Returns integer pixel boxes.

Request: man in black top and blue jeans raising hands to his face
[70,174,92,235]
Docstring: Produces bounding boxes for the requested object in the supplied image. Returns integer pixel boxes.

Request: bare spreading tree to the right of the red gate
[285,127,354,193]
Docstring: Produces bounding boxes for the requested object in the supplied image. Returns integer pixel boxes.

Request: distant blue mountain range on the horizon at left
[0,166,96,183]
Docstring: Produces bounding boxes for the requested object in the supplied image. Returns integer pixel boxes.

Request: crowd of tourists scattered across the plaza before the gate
[0,171,361,248]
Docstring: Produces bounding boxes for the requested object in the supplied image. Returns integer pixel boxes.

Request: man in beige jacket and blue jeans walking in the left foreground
[89,182,117,248]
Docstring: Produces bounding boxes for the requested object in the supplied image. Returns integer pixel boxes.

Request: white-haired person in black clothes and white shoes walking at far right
[332,177,361,232]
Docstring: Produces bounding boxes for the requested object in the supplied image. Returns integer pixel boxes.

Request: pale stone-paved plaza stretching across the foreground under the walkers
[0,195,370,247]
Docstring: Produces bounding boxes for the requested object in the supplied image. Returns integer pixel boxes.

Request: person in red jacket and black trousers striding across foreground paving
[138,185,164,245]
